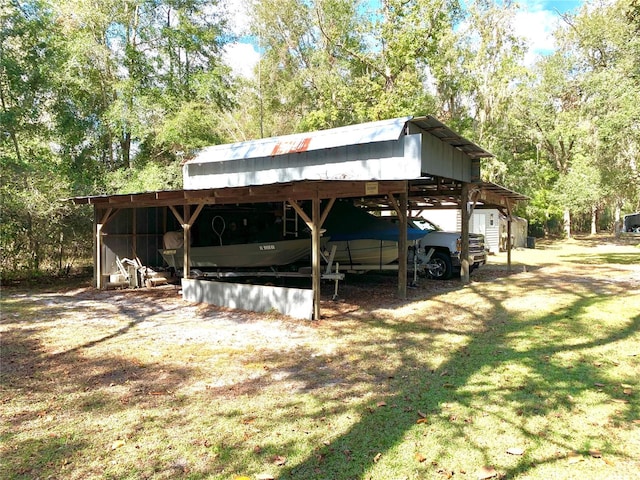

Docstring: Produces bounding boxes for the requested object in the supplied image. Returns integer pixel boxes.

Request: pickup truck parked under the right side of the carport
[412,220,487,280]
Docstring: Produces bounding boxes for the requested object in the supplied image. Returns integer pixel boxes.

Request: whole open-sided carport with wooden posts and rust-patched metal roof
[73,116,526,319]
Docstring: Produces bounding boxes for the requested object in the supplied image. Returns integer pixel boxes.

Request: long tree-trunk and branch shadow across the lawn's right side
[278,272,640,480]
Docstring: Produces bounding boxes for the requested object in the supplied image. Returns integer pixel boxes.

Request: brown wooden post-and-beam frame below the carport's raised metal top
[73,176,526,319]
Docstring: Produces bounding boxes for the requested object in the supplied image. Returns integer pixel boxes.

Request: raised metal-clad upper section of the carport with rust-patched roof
[183,117,478,190]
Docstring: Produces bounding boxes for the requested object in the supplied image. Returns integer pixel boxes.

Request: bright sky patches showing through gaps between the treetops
[226,0,585,76]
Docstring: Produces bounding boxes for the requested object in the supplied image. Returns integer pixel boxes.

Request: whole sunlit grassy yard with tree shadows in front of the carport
[0,237,640,480]
